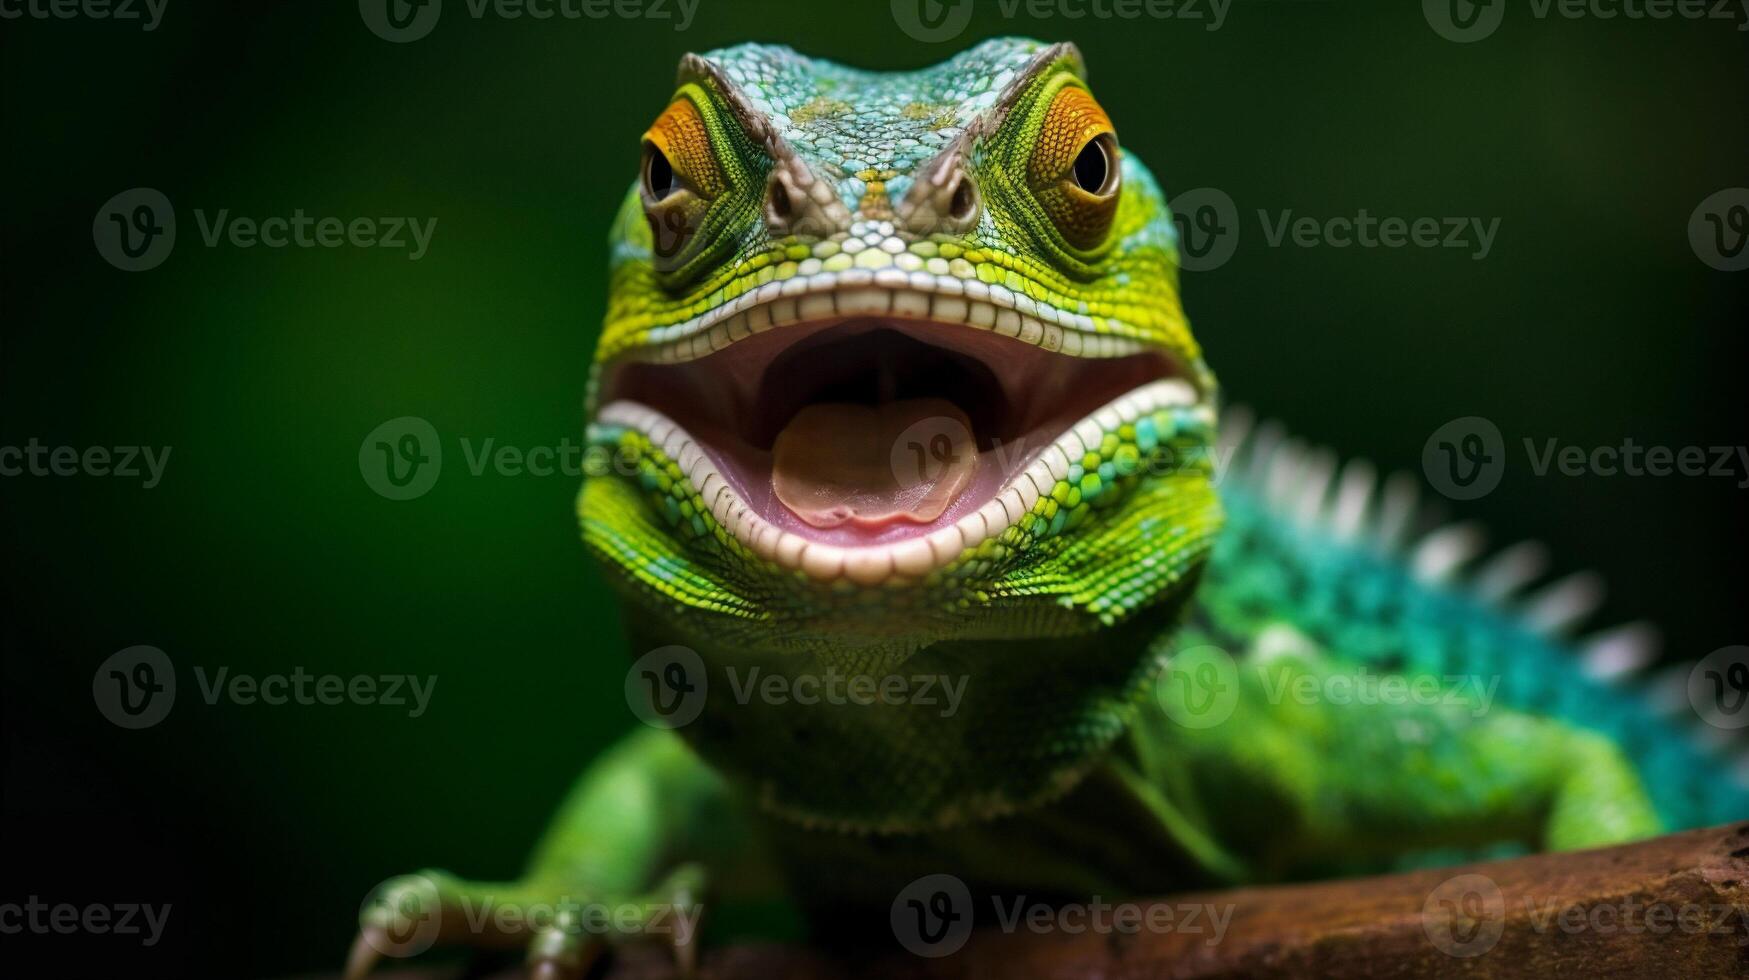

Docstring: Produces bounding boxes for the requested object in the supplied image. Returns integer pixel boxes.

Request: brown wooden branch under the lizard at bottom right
[348,823,1749,980]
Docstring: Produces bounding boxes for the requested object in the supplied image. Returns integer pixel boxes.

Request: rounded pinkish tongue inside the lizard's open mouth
[771,399,978,527]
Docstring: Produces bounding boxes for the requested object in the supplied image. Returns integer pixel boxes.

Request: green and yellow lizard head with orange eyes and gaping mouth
[579,39,1219,649]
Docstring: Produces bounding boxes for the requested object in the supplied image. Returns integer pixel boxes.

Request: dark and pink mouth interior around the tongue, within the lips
[596,280,1200,577]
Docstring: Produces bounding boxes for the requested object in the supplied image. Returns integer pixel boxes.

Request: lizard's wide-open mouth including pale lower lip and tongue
[598,283,1198,581]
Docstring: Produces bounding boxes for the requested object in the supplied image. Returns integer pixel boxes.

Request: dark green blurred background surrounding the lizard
[0,0,1749,977]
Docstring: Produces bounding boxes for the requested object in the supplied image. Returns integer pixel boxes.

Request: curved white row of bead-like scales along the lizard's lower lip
[589,378,1196,586]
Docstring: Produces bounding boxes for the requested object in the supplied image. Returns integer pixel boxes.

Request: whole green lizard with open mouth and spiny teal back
[350,39,1749,977]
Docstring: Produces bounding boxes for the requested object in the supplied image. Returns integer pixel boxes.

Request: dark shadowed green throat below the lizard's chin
[630,574,1196,833]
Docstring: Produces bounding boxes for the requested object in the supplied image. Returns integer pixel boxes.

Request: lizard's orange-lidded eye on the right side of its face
[1027,86,1123,252]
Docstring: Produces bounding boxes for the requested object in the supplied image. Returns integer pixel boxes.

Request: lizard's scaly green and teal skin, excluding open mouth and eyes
[355,39,1749,975]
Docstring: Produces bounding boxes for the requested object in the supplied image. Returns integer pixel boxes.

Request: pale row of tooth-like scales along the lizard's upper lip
[631,268,1142,364]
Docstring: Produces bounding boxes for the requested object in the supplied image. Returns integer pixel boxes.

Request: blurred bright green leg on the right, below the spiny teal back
[1139,632,1662,877]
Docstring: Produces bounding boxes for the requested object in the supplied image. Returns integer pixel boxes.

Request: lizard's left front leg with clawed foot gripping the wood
[346,730,757,980]
